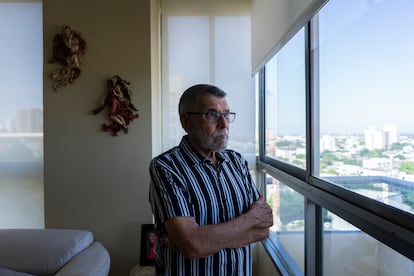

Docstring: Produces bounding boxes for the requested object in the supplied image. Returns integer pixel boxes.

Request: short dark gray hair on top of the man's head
[178,84,227,114]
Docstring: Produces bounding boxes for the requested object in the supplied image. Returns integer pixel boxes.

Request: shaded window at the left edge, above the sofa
[0,1,44,228]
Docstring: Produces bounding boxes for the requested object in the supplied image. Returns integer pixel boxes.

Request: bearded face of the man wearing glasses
[184,96,229,155]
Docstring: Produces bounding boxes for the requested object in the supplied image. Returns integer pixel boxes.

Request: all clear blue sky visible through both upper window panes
[269,0,414,134]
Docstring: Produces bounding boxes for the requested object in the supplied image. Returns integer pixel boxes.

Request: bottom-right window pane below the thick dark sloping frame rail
[322,209,414,276]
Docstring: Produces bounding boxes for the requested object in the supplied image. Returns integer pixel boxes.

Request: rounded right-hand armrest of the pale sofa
[55,241,111,276]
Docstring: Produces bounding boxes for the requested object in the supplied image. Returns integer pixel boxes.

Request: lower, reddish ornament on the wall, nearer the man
[92,75,139,136]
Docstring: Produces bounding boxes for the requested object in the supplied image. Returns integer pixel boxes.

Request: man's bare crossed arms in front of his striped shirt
[162,196,273,259]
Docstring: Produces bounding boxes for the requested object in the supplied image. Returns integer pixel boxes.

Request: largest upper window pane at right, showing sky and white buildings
[313,0,414,216]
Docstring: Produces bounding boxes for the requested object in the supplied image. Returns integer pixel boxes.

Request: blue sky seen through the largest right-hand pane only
[319,0,414,133]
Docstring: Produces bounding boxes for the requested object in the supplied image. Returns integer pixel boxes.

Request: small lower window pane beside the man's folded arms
[266,175,305,272]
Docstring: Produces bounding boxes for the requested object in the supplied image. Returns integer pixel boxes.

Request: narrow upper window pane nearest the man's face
[265,29,306,168]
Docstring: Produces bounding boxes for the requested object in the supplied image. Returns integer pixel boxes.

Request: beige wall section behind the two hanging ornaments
[43,0,152,275]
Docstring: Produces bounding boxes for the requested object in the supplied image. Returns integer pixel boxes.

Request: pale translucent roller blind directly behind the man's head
[161,0,255,166]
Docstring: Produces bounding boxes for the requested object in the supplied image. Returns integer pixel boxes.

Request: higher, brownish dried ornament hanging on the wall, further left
[50,25,86,92]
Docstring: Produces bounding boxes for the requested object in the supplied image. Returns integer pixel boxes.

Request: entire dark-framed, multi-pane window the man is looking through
[255,0,414,275]
